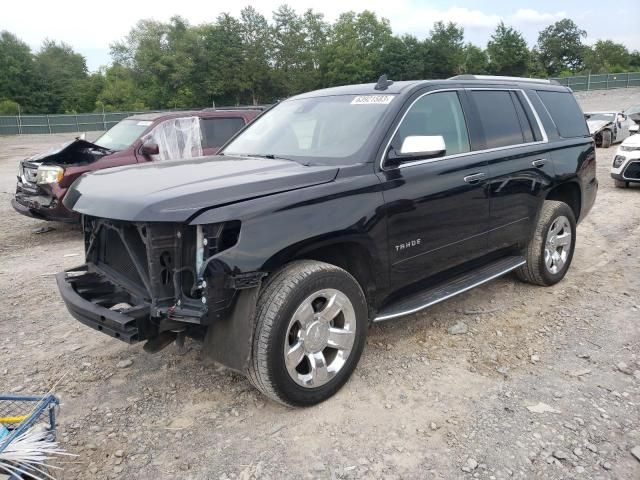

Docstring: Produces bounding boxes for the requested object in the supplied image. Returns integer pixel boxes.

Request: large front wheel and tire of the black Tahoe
[248,260,368,406]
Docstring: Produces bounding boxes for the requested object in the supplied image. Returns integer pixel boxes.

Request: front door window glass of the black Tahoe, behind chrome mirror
[392,92,470,155]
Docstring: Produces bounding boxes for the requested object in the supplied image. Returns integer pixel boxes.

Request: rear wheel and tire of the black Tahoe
[516,200,576,287]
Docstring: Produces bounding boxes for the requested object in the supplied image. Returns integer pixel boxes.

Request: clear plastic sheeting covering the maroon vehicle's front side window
[145,117,202,161]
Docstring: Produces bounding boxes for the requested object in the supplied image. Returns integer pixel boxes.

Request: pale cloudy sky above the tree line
[0,0,640,71]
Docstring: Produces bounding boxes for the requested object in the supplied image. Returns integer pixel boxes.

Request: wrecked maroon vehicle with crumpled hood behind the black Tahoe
[11,107,262,222]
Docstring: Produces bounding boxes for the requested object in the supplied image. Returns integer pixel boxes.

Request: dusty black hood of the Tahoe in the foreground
[64,156,339,222]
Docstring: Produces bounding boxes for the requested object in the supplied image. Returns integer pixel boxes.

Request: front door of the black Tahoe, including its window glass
[379,91,489,287]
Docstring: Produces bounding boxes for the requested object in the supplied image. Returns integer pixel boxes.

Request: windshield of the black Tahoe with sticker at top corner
[224,95,395,163]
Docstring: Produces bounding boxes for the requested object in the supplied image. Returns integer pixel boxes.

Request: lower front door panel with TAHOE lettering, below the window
[379,156,489,288]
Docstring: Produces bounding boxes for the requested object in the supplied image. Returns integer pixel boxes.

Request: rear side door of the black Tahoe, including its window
[468,89,554,251]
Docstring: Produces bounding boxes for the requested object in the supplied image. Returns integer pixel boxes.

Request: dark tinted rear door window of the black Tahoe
[471,90,524,148]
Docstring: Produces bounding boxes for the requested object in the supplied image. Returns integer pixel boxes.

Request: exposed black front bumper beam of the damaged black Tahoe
[56,266,149,343]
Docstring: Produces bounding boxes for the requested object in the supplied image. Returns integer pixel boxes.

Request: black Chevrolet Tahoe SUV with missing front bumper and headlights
[57,76,598,405]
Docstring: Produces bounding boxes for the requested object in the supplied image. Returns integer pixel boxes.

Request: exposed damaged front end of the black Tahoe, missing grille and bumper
[57,217,263,370]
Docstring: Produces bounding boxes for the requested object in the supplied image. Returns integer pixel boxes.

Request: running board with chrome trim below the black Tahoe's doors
[373,256,527,322]
